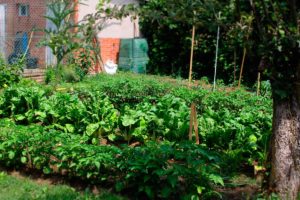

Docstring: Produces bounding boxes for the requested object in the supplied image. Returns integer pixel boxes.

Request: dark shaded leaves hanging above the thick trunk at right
[247,1,300,100]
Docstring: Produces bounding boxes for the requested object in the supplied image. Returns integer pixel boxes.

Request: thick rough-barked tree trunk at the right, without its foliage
[270,95,300,200]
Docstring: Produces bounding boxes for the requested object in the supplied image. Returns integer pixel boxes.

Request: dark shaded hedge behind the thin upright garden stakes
[140,0,248,83]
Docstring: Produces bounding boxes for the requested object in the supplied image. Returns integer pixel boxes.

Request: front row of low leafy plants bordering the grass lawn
[0,120,223,199]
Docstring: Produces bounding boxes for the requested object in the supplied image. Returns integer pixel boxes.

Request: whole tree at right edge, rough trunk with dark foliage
[229,0,300,200]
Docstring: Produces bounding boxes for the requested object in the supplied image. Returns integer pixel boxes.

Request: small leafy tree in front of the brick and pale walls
[41,0,135,72]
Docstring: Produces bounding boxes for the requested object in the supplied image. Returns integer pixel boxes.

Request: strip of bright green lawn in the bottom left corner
[0,172,124,200]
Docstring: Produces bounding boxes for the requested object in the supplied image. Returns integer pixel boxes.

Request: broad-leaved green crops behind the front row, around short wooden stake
[0,73,272,178]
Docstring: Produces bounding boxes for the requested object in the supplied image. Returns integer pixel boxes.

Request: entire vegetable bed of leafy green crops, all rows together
[0,73,272,199]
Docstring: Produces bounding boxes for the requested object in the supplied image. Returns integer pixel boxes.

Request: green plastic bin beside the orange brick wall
[119,38,149,73]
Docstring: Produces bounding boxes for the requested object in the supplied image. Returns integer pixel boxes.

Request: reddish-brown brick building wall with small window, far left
[0,0,46,66]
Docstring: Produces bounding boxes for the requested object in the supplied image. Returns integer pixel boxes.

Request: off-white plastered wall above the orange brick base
[78,0,140,38]
